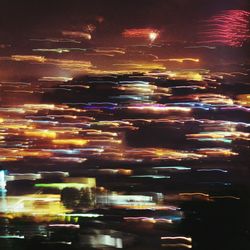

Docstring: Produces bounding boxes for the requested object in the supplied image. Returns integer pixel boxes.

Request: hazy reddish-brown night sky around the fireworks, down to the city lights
[0,0,250,78]
